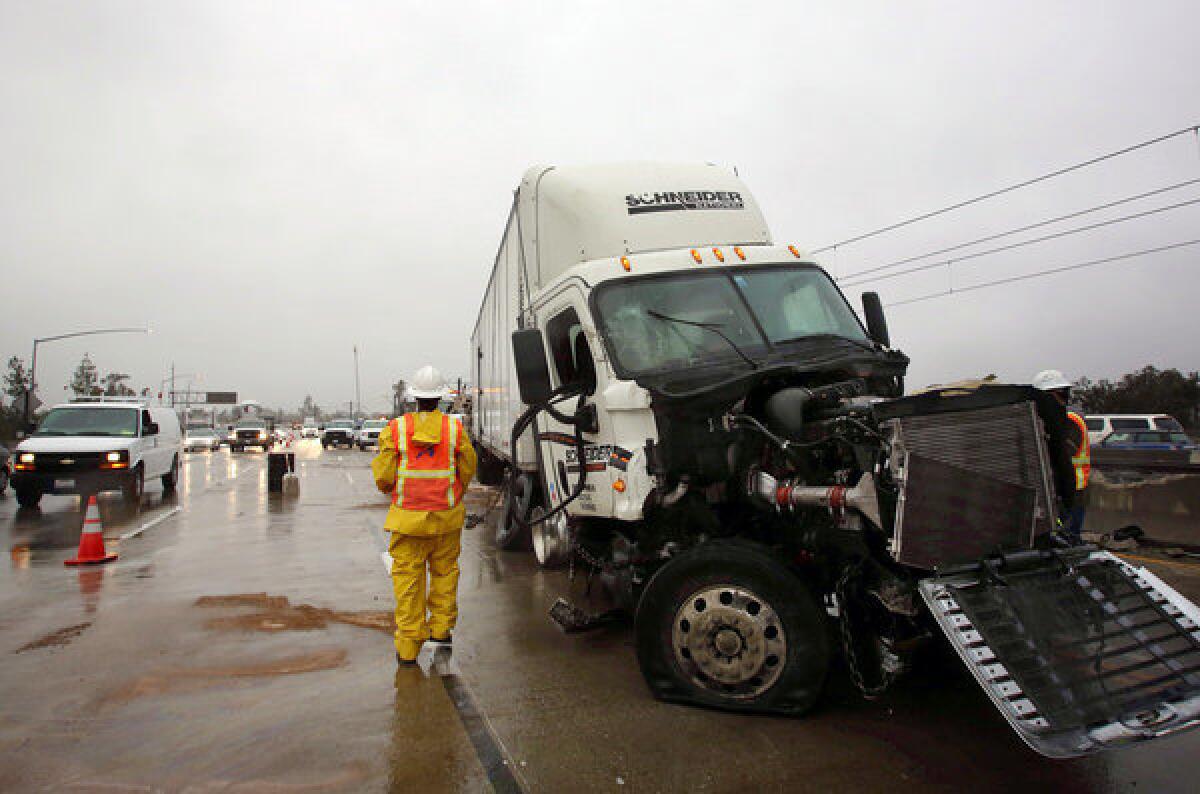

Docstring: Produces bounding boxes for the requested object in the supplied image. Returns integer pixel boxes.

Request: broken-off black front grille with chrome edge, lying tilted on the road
[919,547,1200,758]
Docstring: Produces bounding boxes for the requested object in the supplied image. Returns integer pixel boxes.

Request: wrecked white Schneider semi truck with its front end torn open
[469,163,1200,757]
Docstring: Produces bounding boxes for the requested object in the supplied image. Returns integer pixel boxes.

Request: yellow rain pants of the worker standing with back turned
[388,531,462,658]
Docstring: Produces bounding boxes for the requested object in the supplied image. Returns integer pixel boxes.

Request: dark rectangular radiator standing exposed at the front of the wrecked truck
[884,402,1055,570]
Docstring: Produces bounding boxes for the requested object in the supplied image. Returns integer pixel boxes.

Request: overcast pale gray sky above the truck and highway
[0,0,1200,417]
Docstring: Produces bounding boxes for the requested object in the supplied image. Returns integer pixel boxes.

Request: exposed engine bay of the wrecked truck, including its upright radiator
[578,379,1072,696]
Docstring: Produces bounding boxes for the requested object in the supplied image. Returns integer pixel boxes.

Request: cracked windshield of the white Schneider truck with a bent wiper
[596,266,869,374]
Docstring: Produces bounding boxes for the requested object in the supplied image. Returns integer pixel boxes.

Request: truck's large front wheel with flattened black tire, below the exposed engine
[635,540,829,716]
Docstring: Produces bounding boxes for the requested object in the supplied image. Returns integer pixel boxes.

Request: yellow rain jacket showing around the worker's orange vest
[371,410,475,537]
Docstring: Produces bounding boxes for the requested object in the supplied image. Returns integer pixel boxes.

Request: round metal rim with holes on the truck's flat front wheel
[671,584,787,699]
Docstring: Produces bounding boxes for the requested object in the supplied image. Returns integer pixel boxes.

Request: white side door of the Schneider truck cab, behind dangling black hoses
[538,287,613,517]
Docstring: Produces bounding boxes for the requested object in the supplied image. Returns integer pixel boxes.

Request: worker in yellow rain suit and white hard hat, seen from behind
[371,367,475,664]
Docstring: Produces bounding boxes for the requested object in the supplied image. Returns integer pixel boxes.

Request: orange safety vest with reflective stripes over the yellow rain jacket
[391,414,462,511]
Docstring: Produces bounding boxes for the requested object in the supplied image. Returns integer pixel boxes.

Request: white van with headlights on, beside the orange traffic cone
[12,397,182,507]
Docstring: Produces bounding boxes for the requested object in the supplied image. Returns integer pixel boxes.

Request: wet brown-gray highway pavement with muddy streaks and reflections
[0,441,1200,792]
